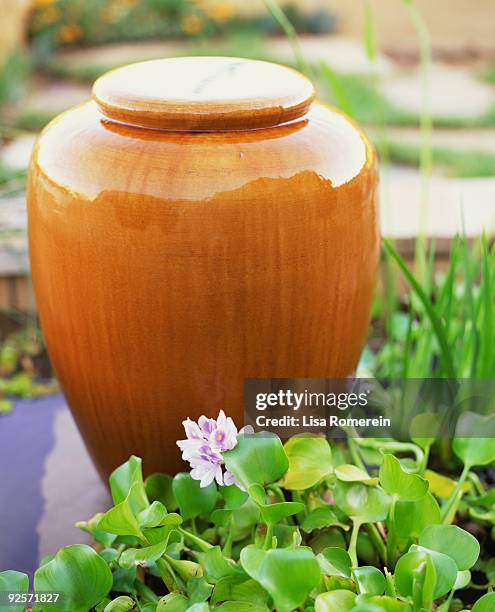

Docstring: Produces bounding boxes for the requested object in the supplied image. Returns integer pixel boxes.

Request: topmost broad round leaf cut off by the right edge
[452,412,495,467]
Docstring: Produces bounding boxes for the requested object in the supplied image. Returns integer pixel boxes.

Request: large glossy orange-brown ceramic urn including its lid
[28,58,379,476]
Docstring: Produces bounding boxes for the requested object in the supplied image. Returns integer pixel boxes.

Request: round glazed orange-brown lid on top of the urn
[93,57,315,131]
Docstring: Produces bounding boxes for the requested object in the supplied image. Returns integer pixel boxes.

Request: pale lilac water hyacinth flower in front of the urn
[177,410,246,489]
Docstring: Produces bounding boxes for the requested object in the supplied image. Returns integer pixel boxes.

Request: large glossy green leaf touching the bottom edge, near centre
[241,546,320,611]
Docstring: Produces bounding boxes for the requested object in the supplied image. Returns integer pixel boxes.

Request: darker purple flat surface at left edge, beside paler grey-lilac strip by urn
[0,395,65,575]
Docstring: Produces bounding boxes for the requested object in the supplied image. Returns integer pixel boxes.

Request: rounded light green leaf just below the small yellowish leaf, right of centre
[334,480,390,523]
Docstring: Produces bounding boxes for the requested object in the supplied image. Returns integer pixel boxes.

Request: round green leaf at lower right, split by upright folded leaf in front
[395,545,457,599]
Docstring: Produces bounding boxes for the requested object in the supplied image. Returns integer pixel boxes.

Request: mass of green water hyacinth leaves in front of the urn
[0,420,495,612]
